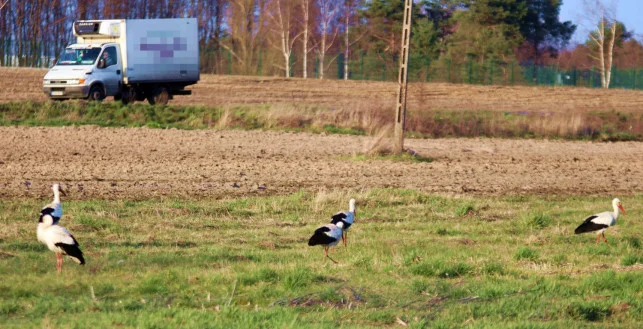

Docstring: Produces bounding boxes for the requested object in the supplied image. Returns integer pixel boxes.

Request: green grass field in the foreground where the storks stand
[0,189,643,329]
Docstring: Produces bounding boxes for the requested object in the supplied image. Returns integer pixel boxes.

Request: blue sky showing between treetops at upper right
[560,0,643,43]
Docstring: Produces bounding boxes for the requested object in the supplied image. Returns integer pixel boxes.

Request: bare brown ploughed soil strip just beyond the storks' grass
[0,126,643,199]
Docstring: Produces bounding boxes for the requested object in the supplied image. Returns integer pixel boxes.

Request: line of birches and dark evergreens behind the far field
[0,0,643,87]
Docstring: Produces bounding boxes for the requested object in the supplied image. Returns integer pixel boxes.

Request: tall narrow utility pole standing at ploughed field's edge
[393,0,413,154]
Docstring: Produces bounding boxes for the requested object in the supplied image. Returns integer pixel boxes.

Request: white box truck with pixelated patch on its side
[43,18,199,104]
